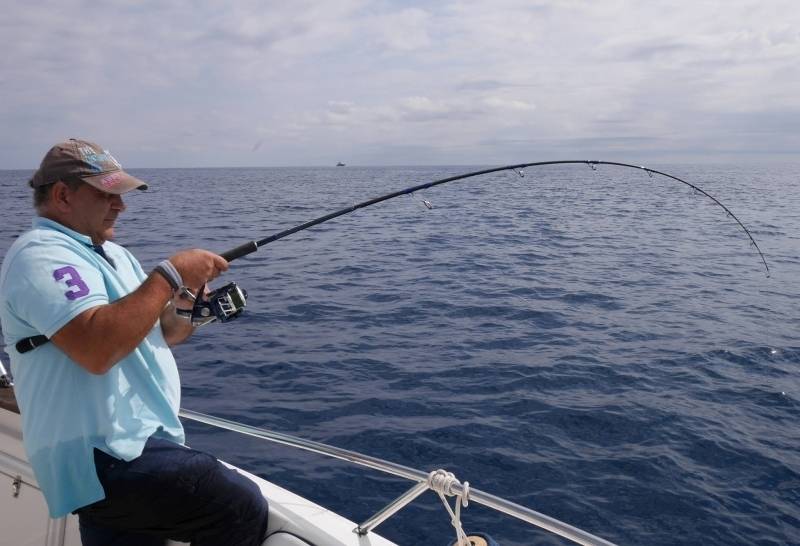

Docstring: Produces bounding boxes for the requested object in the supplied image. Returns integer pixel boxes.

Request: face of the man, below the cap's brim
[69,183,125,245]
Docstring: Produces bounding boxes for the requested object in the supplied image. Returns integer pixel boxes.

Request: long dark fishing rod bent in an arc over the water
[221,160,770,277]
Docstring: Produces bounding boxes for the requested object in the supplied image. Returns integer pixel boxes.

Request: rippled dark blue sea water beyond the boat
[0,164,800,546]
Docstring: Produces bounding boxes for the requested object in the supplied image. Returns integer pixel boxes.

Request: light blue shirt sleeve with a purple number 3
[7,239,108,337]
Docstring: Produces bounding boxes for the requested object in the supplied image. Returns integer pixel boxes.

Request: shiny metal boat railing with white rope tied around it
[179,409,614,546]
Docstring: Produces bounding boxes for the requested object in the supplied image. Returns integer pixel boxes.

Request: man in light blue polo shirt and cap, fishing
[0,139,267,546]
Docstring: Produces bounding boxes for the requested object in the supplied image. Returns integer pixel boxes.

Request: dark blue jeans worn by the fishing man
[76,438,268,546]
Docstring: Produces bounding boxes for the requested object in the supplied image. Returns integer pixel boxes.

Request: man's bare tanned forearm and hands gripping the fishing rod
[51,250,228,374]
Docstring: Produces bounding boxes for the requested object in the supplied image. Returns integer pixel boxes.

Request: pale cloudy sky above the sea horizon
[0,0,800,169]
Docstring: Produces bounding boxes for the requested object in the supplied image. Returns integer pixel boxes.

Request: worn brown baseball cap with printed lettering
[30,138,147,195]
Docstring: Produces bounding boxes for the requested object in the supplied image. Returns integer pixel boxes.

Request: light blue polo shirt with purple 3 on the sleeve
[0,217,184,518]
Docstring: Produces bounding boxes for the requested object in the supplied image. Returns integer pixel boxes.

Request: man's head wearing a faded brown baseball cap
[29,139,147,244]
